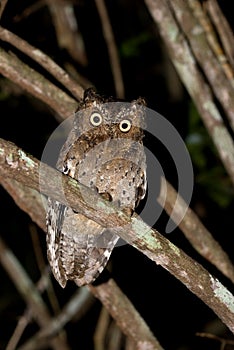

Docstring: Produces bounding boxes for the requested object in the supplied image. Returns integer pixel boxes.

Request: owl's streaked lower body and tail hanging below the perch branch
[47,200,118,287]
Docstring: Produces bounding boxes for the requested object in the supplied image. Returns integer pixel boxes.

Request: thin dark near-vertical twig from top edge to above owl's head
[95,0,124,98]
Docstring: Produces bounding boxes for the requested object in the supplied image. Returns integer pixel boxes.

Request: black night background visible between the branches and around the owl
[0,0,234,350]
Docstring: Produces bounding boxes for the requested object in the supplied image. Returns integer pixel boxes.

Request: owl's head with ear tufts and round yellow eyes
[74,88,145,141]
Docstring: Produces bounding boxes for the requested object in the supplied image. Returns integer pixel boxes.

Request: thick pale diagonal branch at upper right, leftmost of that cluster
[145,0,234,183]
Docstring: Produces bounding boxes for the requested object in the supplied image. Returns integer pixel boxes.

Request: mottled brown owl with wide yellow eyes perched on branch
[46,88,146,287]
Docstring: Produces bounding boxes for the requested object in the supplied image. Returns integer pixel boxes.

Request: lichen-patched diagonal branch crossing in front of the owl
[0,139,234,333]
